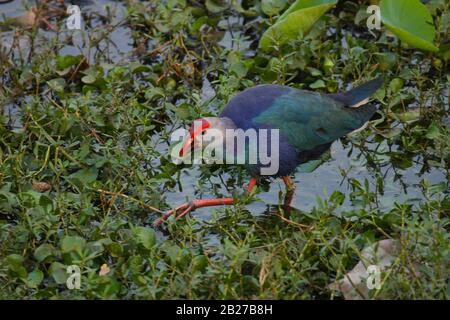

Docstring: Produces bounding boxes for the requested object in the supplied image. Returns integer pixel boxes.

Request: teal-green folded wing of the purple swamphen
[253,89,376,152]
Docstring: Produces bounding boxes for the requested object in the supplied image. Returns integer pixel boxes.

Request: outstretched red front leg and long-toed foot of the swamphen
[155,177,257,226]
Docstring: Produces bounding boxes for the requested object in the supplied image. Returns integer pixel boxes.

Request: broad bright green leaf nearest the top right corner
[380,0,438,51]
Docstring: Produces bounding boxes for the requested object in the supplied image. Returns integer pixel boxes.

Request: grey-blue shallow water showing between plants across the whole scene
[0,0,446,225]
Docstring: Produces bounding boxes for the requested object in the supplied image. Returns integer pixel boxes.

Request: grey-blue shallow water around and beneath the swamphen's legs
[165,136,446,219]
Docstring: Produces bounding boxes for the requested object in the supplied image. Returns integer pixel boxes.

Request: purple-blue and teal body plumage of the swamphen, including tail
[221,79,382,175]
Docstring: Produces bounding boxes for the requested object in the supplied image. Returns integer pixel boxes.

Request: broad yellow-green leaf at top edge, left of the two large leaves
[259,0,337,50]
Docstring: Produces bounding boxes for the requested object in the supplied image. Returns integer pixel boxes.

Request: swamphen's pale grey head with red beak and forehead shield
[179,117,235,157]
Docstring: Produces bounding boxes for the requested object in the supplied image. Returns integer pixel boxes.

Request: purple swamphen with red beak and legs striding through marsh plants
[155,77,383,225]
